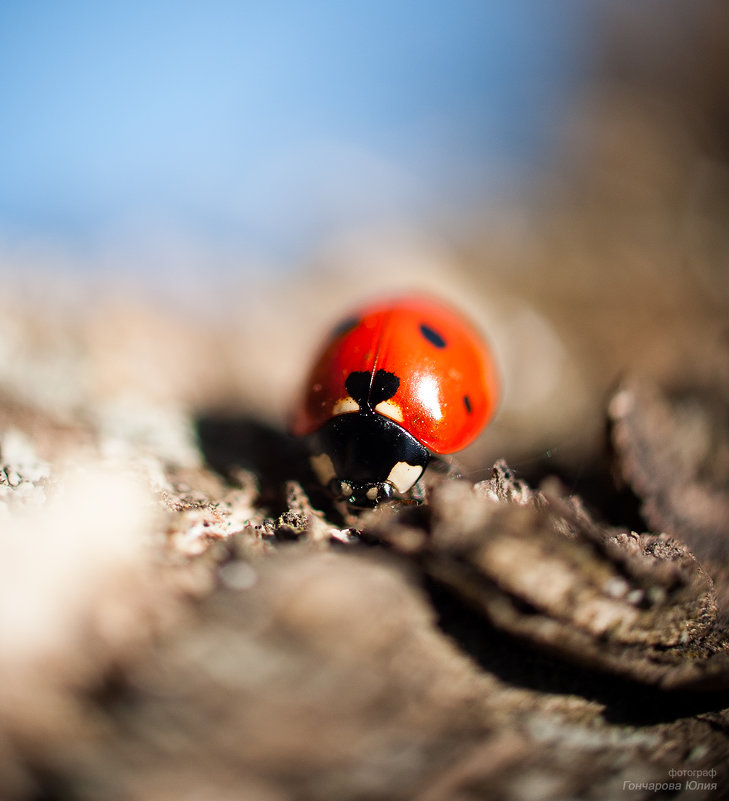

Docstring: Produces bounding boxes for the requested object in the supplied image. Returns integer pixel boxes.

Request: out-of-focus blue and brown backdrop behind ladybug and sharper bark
[0,0,729,488]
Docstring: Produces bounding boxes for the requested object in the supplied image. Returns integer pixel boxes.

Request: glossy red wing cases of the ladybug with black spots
[292,297,499,454]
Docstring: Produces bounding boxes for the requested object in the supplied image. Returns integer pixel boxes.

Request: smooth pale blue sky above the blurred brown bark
[0,0,594,266]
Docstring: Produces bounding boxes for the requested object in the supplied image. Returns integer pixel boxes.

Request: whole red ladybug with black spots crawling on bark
[292,297,499,509]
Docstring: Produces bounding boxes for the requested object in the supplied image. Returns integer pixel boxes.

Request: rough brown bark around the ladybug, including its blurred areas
[0,3,729,801]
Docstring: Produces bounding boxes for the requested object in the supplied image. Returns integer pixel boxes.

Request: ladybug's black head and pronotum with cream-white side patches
[311,411,430,509]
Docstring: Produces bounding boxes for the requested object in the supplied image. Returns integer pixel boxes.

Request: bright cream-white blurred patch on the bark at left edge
[0,460,159,684]
